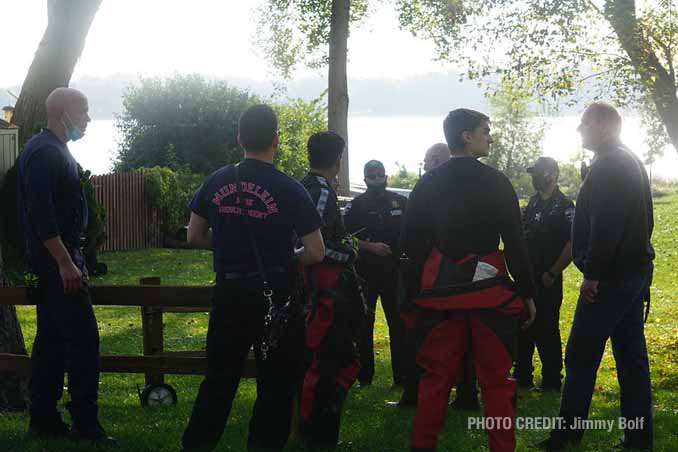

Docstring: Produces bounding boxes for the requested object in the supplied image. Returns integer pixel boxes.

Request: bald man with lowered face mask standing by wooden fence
[17,88,114,445]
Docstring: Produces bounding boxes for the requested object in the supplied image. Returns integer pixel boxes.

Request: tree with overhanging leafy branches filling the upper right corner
[396,0,678,150]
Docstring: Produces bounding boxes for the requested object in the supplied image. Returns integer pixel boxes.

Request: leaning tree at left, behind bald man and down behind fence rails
[0,0,101,410]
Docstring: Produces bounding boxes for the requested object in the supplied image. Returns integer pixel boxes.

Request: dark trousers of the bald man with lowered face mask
[29,264,99,431]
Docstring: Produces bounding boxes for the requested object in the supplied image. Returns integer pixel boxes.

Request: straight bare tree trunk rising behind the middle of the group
[327,0,351,196]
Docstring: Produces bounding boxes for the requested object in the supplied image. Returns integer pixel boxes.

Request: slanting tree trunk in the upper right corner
[605,0,678,150]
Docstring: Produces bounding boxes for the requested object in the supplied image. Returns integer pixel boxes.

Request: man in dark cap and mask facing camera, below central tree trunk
[344,160,407,385]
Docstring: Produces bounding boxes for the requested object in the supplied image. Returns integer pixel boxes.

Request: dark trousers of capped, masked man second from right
[514,275,563,389]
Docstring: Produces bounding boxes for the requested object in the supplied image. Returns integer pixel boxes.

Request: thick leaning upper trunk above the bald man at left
[12,0,102,147]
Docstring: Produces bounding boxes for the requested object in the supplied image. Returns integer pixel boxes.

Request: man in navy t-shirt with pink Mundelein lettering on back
[182,105,325,451]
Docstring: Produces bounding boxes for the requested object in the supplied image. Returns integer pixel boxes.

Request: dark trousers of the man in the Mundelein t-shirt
[182,275,304,450]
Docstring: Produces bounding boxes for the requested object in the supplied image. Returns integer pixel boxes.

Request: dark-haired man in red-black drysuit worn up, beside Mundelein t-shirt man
[301,132,365,448]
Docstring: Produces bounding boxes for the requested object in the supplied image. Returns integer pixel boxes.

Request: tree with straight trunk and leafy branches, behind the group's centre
[258,0,367,195]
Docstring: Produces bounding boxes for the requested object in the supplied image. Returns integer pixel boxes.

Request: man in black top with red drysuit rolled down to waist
[402,109,535,452]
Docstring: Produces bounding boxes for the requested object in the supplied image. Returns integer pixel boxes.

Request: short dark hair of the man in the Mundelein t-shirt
[238,104,278,152]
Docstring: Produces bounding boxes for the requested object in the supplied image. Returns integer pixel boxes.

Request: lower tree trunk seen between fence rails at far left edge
[0,260,28,411]
